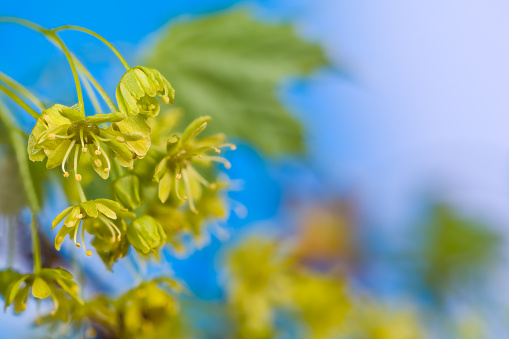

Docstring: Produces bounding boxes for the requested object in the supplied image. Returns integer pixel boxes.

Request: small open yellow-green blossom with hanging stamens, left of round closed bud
[51,199,136,256]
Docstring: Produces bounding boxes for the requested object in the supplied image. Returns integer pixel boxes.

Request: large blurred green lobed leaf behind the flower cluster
[146,10,327,154]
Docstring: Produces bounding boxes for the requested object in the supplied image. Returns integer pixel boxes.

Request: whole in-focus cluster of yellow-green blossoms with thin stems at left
[0,18,235,337]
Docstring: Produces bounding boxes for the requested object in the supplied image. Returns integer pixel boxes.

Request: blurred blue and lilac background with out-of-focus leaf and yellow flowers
[0,0,509,339]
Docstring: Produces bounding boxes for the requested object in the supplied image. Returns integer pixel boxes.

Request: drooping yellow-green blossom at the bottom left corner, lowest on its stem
[5,267,78,312]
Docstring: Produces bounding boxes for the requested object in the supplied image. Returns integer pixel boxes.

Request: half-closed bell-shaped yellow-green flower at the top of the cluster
[116,66,175,117]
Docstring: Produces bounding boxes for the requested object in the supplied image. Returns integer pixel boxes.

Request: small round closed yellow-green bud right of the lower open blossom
[127,215,166,255]
